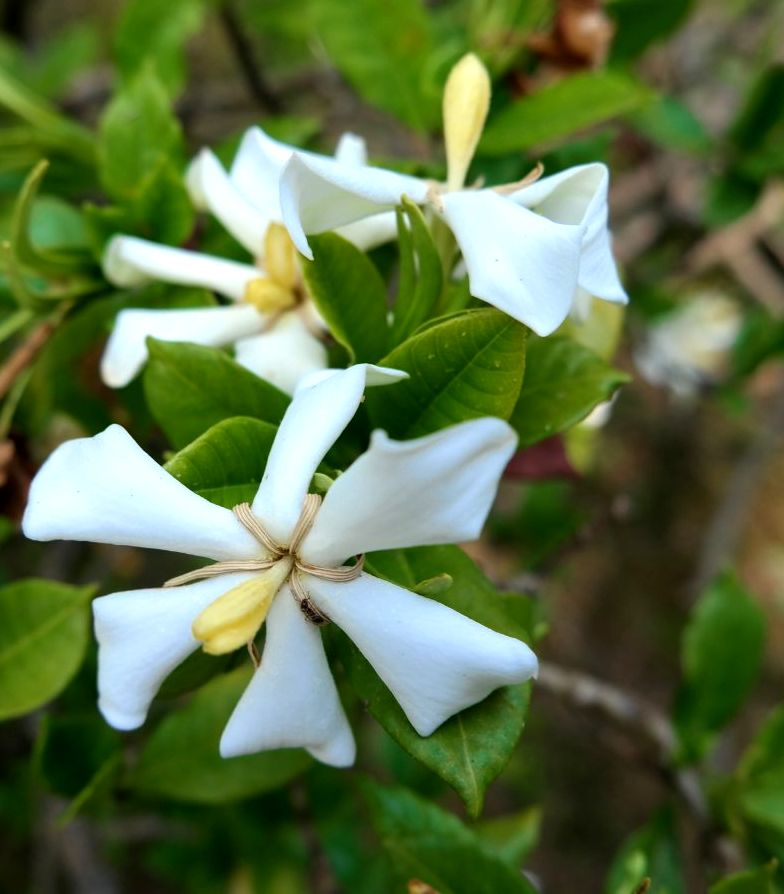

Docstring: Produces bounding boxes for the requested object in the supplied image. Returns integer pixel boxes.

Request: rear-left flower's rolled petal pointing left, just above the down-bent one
[103,236,261,301]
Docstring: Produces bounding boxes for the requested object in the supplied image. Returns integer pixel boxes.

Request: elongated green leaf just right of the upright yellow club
[478,71,652,155]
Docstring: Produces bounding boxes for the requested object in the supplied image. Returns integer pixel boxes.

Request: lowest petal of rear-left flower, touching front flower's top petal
[234,313,327,394]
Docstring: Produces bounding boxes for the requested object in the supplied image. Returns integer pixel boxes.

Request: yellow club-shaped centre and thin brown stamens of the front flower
[164,494,364,655]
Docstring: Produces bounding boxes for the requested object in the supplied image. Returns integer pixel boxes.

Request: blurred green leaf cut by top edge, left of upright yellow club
[314,0,440,130]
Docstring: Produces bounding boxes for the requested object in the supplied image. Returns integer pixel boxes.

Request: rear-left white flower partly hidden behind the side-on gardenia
[101,128,395,393]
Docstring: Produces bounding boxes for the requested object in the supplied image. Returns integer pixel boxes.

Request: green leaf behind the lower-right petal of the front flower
[339,546,532,816]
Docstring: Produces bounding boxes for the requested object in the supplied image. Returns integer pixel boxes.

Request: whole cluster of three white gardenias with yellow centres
[24,55,626,766]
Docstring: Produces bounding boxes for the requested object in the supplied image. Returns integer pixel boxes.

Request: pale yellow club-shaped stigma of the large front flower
[191,556,294,655]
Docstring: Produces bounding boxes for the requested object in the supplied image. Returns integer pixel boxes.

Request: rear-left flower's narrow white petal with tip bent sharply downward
[101,304,266,388]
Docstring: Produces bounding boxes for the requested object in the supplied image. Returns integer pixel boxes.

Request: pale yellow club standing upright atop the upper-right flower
[444,53,491,191]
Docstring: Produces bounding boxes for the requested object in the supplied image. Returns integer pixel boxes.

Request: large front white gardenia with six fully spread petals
[23,365,537,766]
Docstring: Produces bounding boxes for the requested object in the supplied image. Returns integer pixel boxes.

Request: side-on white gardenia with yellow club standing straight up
[280,54,627,335]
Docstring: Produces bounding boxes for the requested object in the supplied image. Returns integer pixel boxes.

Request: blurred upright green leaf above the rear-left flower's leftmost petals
[98,68,182,201]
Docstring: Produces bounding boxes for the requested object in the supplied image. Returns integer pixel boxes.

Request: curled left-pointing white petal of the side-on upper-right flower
[280,153,429,258]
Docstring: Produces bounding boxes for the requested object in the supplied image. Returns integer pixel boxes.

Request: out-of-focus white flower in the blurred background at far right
[634,292,742,400]
